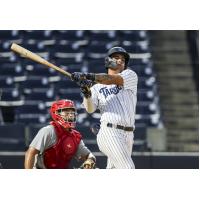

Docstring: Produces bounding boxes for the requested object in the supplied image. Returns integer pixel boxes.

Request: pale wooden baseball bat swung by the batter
[11,43,71,78]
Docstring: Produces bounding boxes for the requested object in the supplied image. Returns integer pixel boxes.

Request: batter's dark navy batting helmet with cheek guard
[105,47,130,69]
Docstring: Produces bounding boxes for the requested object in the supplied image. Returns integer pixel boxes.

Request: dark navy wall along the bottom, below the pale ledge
[0,155,199,169]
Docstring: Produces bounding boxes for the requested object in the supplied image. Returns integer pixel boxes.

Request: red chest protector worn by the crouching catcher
[43,122,82,169]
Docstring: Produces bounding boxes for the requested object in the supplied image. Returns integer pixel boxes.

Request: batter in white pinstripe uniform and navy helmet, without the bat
[72,47,138,169]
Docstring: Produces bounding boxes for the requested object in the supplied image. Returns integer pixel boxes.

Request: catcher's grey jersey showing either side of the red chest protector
[30,125,91,168]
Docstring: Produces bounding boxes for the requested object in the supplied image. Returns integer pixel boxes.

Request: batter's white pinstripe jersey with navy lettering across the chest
[91,69,138,127]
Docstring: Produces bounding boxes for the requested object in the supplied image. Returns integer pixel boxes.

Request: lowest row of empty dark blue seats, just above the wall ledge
[0,122,146,152]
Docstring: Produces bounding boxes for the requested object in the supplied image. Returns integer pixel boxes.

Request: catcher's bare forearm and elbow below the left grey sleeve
[24,147,39,169]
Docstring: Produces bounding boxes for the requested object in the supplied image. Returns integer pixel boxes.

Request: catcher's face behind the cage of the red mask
[58,108,76,122]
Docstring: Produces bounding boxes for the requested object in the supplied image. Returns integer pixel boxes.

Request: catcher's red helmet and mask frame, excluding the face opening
[50,99,76,128]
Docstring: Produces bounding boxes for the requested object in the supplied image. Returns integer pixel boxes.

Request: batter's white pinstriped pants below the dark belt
[97,125,135,169]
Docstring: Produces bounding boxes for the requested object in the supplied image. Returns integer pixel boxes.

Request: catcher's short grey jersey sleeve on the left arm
[29,127,53,153]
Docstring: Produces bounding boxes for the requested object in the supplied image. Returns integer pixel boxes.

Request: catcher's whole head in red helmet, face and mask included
[50,99,77,128]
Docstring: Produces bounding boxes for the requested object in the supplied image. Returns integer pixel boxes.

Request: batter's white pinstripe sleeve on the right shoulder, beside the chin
[119,69,138,92]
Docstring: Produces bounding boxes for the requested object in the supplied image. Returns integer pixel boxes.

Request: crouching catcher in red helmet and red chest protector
[25,100,96,169]
